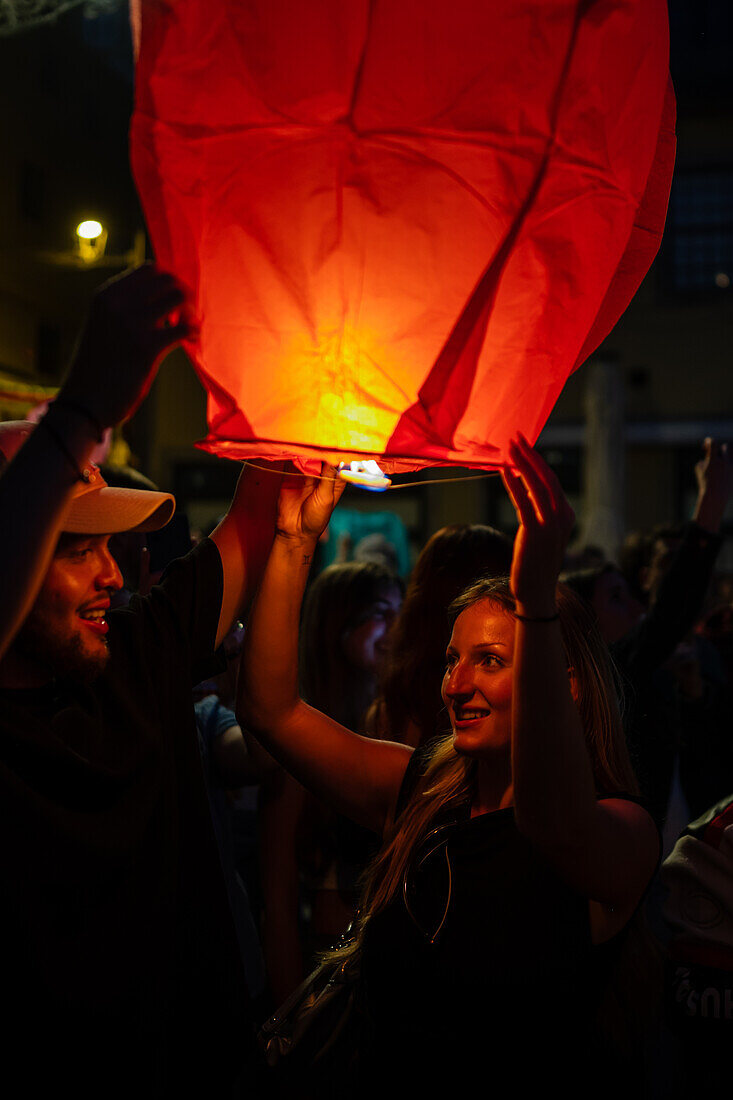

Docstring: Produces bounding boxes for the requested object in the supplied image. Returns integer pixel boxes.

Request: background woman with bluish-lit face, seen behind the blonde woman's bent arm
[260,561,403,1003]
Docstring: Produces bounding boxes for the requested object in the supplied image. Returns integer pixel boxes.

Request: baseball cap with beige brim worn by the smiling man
[0,420,176,535]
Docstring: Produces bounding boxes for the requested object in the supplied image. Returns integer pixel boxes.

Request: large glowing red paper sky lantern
[131,0,675,472]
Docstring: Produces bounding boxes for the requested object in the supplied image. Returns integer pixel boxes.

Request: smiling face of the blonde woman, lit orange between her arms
[442,600,514,758]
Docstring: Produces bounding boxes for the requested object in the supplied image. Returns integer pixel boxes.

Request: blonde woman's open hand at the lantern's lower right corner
[502,433,576,617]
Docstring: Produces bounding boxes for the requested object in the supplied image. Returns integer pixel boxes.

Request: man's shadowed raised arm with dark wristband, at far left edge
[0,264,195,659]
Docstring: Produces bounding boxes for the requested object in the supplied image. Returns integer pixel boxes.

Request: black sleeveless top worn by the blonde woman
[352,748,633,1098]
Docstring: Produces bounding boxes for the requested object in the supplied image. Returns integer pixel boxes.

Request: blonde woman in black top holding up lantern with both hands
[240,437,659,1097]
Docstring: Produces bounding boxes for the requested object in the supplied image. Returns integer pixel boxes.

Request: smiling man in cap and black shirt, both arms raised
[0,265,278,1098]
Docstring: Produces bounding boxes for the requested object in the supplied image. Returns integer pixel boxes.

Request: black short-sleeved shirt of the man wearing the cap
[0,539,251,1098]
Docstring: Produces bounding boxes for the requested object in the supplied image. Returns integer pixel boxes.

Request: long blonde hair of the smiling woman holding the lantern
[331,578,637,957]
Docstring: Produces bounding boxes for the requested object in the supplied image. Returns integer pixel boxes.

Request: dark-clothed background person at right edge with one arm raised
[561,439,733,853]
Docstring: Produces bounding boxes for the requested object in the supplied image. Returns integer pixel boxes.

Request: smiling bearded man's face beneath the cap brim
[12,535,122,682]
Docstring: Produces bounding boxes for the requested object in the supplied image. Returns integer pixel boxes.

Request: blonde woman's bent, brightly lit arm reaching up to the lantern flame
[237,464,411,833]
